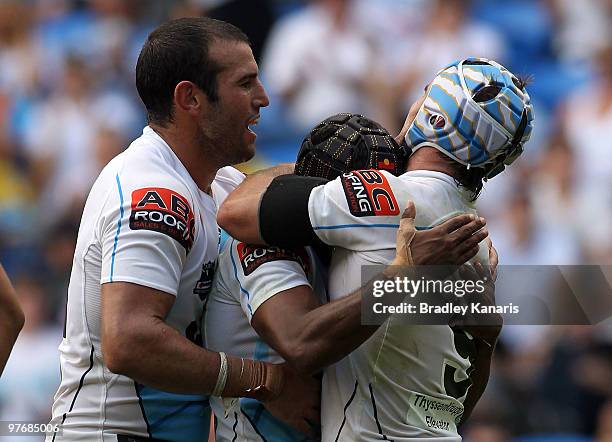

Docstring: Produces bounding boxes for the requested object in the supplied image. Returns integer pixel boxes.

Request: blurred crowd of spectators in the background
[0,0,612,442]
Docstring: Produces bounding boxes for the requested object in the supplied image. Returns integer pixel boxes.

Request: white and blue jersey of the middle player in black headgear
[203,237,326,442]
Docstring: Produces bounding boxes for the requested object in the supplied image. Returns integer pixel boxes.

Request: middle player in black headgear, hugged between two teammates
[204,116,487,441]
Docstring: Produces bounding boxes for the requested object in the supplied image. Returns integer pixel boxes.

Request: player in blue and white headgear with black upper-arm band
[218,58,533,441]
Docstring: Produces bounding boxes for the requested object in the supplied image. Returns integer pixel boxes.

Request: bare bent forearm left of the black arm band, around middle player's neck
[217,163,294,244]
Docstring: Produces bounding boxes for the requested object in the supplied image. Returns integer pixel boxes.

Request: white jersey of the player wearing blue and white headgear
[309,170,487,441]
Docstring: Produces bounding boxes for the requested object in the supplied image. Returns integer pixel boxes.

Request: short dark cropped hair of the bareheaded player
[136,17,250,126]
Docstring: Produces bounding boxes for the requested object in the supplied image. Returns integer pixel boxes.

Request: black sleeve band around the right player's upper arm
[259,175,327,248]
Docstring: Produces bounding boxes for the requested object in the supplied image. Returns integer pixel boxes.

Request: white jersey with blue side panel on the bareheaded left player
[47,127,244,442]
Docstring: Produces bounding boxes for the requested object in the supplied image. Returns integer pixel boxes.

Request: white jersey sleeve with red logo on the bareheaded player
[97,173,195,296]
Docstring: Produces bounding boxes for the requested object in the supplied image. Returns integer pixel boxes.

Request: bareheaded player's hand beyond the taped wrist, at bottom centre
[262,364,321,438]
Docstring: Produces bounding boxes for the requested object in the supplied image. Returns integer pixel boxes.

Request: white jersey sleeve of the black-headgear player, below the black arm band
[229,240,312,322]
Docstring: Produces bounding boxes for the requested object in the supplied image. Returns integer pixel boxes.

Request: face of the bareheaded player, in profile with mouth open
[200,41,269,164]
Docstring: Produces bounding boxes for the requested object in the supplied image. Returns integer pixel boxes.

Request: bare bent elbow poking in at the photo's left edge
[0,266,24,375]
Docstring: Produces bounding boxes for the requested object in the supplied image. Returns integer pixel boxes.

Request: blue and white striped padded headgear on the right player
[405,58,533,178]
